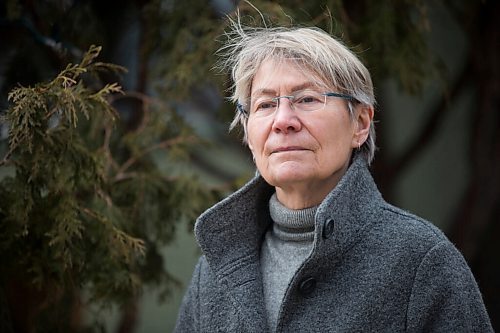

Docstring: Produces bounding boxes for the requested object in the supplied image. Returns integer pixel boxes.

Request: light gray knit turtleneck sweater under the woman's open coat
[260,193,318,331]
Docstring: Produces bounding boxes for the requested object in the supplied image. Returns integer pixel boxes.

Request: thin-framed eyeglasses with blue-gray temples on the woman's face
[237,90,357,116]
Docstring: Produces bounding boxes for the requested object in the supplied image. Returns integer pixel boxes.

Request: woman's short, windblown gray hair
[218,21,376,164]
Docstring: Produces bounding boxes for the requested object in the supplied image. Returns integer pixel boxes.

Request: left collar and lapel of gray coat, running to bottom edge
[195,177,274,332]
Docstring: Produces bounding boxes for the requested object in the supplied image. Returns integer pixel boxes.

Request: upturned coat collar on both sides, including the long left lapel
[195,154,382,331]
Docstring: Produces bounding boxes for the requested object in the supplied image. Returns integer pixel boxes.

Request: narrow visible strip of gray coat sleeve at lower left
[174,258,202,333]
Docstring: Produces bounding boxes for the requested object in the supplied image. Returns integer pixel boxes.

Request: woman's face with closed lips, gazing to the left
[247,60,364,209]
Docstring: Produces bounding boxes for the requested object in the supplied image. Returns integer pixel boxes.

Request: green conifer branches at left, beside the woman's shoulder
[0,46,214,330]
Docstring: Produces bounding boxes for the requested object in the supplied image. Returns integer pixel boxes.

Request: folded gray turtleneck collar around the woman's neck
[269,193,318,242]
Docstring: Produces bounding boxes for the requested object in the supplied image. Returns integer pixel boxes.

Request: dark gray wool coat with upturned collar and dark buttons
[175,156,493,333]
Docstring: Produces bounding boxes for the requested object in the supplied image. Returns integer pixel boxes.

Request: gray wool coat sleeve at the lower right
[407,241,493,332]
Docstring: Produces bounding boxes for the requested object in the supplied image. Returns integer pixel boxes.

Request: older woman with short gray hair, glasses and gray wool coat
[176,27,492,332]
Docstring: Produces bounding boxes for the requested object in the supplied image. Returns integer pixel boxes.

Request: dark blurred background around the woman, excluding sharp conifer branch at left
[0,0,500,332]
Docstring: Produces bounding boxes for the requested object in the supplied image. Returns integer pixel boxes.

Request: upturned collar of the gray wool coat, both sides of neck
[195,154,383,262]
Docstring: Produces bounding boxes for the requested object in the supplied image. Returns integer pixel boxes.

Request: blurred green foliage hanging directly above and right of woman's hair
[227,0,439,94]
